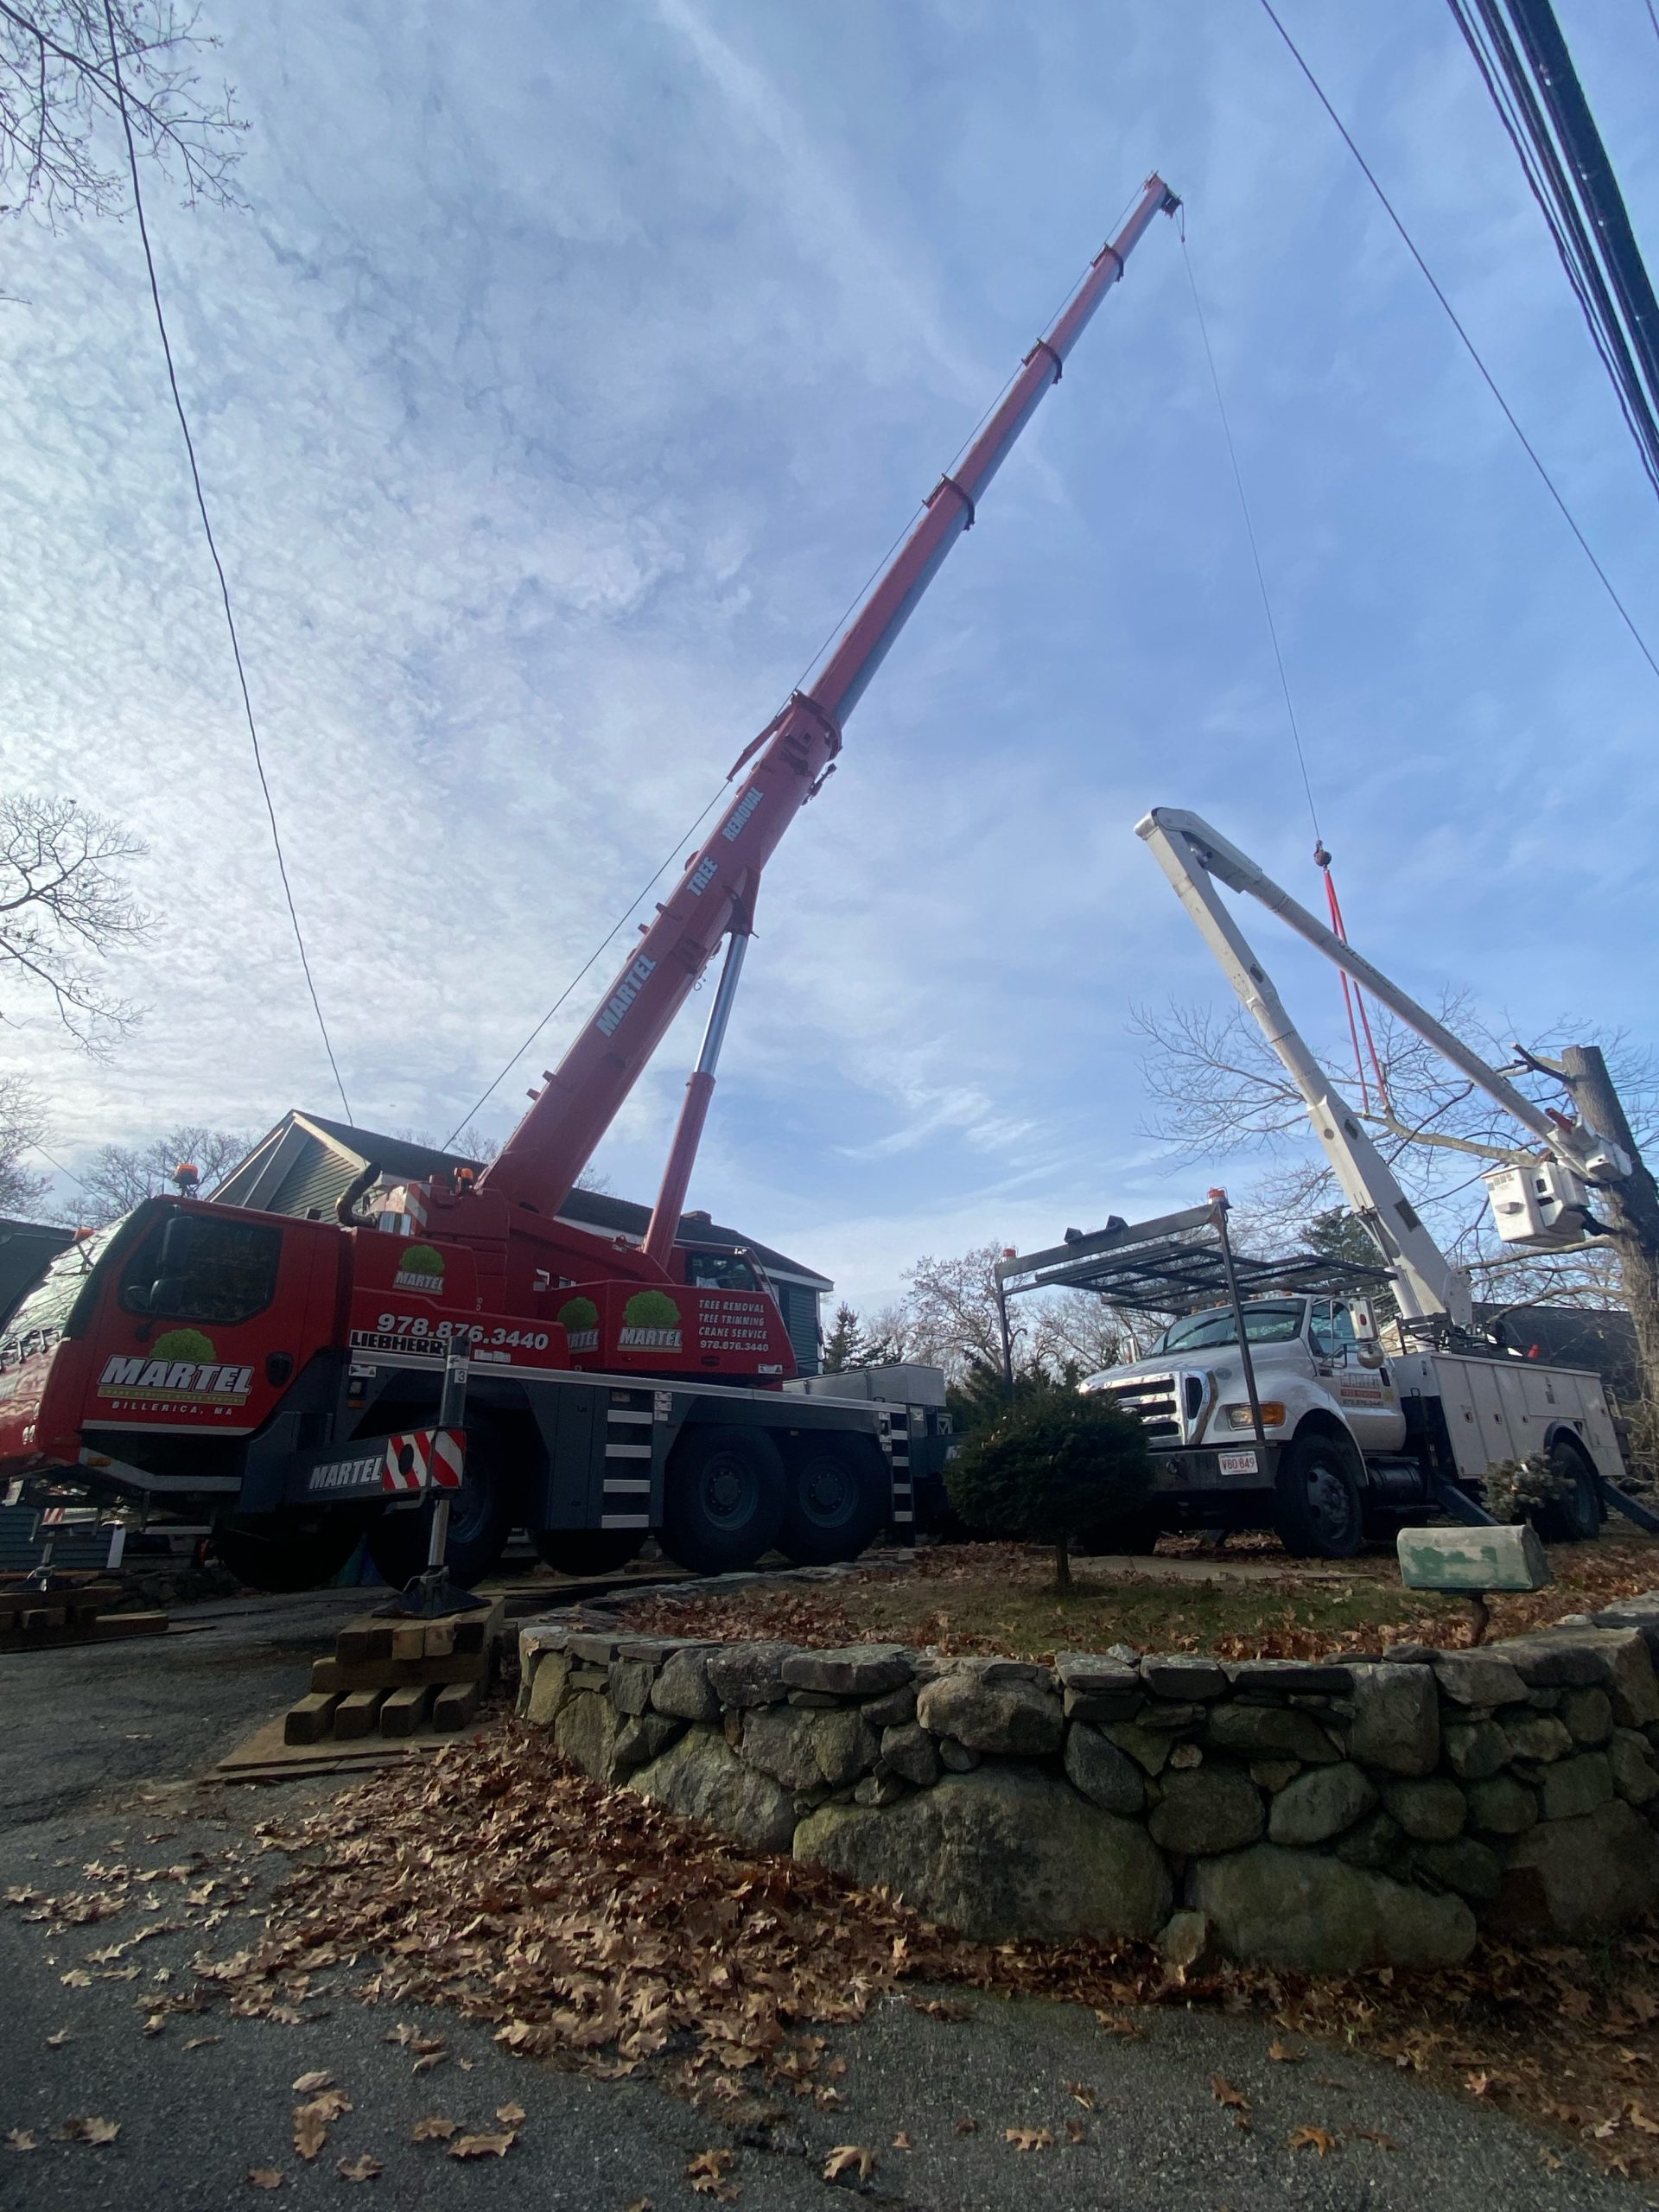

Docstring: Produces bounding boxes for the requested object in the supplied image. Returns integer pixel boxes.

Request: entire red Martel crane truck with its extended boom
[0,177,1177,1588]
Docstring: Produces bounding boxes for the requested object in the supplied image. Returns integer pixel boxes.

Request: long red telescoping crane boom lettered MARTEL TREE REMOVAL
[480,175,1179,1214]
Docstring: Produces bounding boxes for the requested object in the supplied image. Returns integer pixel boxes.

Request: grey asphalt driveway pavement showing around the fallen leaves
[0,1592,1659,2212]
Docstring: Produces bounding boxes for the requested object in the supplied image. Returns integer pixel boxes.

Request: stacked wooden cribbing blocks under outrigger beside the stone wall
[283,1599,505,1752]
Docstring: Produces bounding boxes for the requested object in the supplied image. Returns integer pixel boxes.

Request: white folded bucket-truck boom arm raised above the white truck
[1135,807,1630,1327]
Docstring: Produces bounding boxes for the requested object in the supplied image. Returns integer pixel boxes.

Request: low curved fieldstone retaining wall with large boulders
[520,1592,1659,1974]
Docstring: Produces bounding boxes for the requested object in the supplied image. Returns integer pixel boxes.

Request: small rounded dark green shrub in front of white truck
[944,1389,1153,1591]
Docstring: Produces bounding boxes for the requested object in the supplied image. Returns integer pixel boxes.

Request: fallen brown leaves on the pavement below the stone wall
[16,1721,1659,2167]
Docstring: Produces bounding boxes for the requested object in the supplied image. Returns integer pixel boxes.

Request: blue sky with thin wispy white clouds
[0,0,1659,1300]
